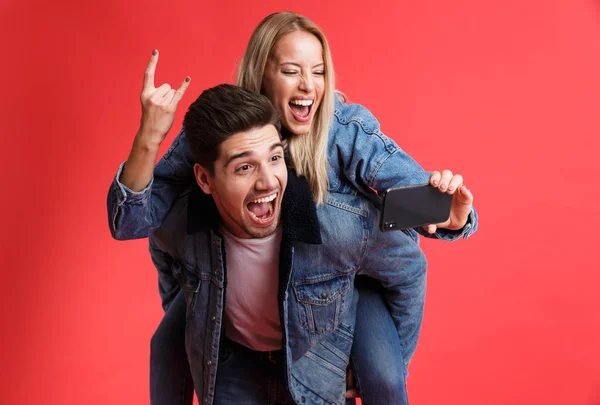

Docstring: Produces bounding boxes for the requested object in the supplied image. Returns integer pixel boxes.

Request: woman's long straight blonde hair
[237,11,335,203]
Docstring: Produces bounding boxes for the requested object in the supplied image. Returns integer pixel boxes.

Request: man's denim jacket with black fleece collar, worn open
[150,171,425,405]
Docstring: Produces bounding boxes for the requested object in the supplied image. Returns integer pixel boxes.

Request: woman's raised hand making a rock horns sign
[138,49,191,147]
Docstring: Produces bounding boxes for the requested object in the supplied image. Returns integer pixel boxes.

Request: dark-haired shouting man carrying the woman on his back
[138,85,472,405]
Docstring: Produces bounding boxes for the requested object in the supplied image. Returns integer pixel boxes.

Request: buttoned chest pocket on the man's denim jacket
[294,274,350,333]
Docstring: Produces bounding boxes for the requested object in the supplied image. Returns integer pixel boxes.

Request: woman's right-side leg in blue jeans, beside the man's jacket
[351,277,408,405]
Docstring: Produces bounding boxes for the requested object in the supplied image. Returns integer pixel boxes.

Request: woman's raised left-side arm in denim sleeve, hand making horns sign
[107,50,194,240]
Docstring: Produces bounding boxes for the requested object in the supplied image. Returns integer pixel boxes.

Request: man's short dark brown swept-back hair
[183,84,281,174]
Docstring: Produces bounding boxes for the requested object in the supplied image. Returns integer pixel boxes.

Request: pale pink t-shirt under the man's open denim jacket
[221,227,281,351]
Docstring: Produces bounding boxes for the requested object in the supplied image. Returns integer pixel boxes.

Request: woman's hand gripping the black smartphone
[424,170,473,233]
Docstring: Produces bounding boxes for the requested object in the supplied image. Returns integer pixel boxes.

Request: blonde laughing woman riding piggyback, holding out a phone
[109,12,476,405]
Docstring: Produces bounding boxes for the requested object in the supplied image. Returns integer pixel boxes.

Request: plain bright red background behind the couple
[0,0,600,405]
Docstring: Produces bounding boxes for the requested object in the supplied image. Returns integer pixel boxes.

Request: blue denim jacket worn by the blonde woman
[107,95,478,240]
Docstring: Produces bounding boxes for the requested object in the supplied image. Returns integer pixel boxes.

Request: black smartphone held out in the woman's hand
[379,184,452,232]
